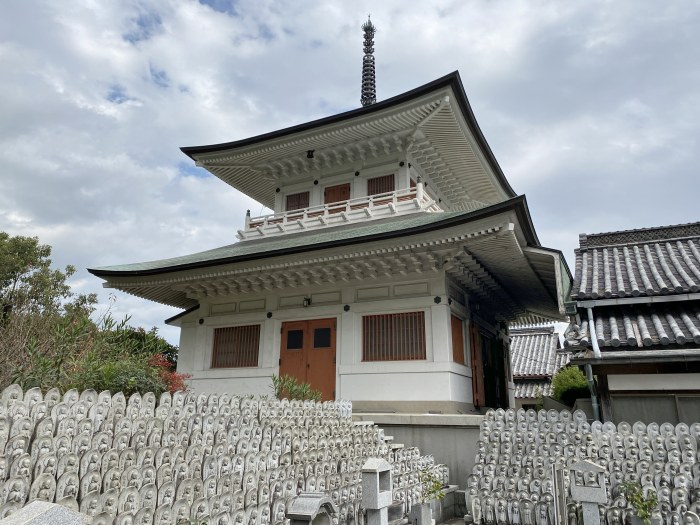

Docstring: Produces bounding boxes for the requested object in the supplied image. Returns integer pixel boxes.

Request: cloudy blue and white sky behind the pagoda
[0,0,700,342]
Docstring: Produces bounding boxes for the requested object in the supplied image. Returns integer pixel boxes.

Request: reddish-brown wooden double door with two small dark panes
[279,319,336,401]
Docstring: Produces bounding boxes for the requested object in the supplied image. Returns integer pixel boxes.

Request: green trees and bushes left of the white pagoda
[0,232,185,395]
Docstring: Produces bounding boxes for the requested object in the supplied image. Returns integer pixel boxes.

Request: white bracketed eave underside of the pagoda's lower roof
[90,198,568,314]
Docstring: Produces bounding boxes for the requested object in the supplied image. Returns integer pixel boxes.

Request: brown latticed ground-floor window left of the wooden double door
[211,324,260,368]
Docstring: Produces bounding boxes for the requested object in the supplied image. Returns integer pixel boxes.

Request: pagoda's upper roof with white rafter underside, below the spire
[181,71,516,210]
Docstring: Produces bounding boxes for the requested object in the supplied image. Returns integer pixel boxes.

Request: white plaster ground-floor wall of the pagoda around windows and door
[173,272,484,403]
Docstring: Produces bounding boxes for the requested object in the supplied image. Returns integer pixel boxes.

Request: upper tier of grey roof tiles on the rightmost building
[571,222,700,301]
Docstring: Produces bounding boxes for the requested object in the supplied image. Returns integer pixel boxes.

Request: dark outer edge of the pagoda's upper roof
[180,71,517,198]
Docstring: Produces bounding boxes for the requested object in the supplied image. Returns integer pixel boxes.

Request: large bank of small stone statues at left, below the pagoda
[0,385,449,525]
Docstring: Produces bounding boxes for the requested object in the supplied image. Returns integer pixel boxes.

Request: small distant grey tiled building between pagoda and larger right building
[510,326,571,406]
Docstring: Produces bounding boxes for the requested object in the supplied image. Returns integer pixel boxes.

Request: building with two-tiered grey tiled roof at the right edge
[566,222,700,421]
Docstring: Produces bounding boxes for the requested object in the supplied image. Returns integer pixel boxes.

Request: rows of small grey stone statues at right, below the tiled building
[466,409,700,525]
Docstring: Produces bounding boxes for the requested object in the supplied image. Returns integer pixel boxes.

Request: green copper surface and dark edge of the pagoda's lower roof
[88,197,539,276]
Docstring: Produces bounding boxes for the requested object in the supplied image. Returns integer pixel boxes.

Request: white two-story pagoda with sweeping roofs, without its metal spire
[90,72,571,412]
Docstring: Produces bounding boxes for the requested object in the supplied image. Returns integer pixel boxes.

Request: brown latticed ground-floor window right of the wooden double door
[362,312,425,361]
